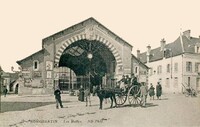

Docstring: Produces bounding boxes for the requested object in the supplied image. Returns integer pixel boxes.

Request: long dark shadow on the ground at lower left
[1,101,69,113]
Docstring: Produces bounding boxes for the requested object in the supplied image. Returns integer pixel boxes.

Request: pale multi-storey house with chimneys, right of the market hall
[137,30,200,93]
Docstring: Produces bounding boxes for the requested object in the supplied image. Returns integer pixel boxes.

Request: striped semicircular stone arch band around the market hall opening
[54,34,123,70]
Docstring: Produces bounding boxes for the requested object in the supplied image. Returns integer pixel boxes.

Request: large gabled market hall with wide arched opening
[17,18,148,94]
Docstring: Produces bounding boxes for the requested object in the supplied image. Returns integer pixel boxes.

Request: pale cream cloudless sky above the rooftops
[0,0,200,72]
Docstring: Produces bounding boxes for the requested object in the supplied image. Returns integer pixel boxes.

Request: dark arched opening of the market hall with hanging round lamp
[58,39,116,88]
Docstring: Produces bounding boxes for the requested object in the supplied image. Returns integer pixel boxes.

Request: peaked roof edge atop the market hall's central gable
[42,17,133,48]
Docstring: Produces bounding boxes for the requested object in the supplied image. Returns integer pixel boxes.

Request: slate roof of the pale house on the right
[139,35,200,63]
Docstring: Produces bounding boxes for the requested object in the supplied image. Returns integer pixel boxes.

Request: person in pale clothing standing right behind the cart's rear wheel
[140,83,148,107]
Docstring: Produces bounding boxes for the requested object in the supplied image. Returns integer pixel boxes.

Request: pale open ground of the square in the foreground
[0,94,200,127]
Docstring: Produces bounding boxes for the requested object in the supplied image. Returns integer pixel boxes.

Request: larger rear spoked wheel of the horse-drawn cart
[128,86,141,106]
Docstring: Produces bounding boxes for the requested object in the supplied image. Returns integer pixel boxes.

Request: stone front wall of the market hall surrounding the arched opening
[17,18,138,94]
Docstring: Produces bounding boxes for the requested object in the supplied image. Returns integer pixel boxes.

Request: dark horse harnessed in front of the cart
[95,87,117,109]
